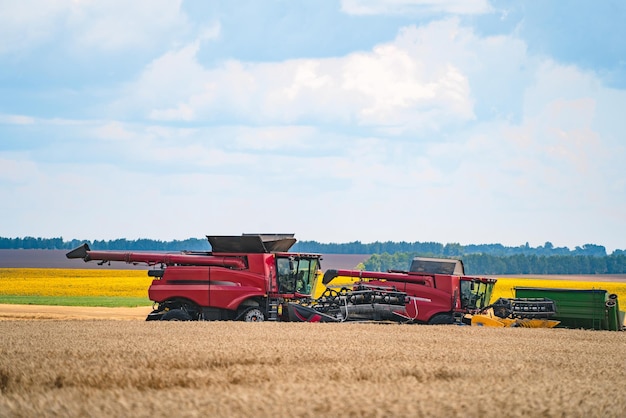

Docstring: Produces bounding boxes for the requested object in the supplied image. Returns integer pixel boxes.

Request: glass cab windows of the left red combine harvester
[276,256,319,295]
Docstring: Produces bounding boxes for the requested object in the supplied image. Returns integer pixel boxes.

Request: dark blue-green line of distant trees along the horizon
[0,237,626,275]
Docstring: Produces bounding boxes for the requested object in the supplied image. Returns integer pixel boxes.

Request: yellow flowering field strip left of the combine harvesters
[0,268,152,299]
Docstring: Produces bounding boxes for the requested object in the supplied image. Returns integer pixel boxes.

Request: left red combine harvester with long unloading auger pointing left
[66,234,321,321]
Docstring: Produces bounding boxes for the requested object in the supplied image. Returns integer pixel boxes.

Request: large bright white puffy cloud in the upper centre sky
[122,20,474,133]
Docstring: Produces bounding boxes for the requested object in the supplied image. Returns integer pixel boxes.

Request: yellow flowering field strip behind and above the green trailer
[491,278,626,306]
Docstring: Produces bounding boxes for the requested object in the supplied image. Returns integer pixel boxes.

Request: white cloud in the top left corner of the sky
[0,0,189,54]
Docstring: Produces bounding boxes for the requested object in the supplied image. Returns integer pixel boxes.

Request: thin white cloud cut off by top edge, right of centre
[341,0,492,15]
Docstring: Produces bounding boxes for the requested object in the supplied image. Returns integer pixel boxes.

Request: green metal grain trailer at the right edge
[515,287,624,331]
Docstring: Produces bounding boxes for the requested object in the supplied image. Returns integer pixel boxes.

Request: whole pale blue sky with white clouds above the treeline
[0,0,626,251]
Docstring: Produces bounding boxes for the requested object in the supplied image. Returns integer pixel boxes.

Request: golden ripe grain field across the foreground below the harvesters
[0,320,626,417]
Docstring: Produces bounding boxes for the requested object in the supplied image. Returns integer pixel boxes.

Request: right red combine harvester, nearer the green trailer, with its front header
[289,257,496,325]
